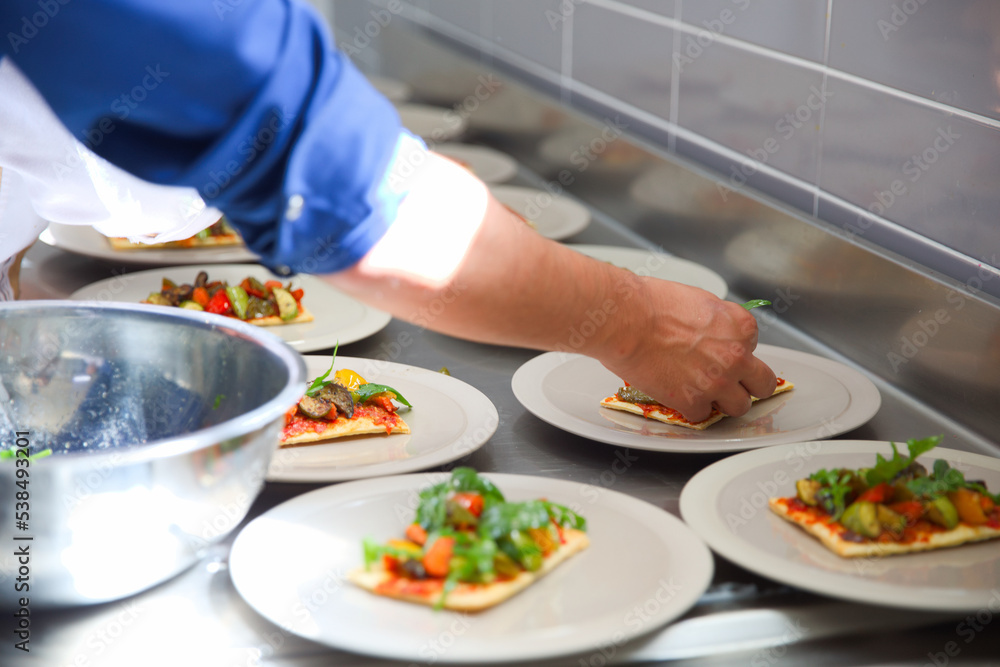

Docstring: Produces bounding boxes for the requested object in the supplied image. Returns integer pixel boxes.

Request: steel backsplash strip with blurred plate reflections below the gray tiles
[370,20,1000,453]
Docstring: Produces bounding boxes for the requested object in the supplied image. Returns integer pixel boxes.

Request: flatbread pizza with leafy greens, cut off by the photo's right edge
[768,437,1000,558]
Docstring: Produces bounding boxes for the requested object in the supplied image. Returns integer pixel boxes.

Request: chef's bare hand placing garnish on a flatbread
[593,278,775,421]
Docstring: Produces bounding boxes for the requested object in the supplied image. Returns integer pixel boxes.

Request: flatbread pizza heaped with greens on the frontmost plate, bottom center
[347,468,590,612]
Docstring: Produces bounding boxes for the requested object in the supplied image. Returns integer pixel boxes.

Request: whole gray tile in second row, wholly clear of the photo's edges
[677,42,824,184]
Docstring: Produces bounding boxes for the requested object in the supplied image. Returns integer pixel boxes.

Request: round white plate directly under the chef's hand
[511,345,881,453]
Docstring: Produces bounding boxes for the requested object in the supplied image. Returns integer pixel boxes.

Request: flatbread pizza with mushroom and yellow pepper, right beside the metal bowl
[281,352,412,447]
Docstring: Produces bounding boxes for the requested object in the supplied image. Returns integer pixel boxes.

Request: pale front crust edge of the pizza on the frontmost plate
[347,528,590,612]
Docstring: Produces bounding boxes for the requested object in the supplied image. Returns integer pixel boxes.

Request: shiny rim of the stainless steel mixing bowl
[0,299,306,464]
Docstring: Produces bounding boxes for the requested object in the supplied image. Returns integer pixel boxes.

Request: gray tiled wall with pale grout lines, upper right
[333,0,1000,296]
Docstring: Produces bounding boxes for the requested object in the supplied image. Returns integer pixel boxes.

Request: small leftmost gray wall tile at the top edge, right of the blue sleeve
[492,0,566,72]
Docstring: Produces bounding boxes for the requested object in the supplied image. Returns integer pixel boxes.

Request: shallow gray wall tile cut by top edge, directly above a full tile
[681,0,827,62]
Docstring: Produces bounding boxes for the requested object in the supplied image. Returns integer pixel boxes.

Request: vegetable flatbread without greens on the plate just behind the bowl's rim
[142,271,313,327]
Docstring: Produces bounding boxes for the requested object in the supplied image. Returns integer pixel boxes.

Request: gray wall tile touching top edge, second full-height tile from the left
[572,5,673,119]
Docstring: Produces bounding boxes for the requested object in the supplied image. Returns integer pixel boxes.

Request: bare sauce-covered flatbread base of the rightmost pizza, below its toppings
[768,498,1000,558]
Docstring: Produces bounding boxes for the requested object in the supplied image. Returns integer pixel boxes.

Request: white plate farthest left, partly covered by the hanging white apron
[38,222,257,266]
